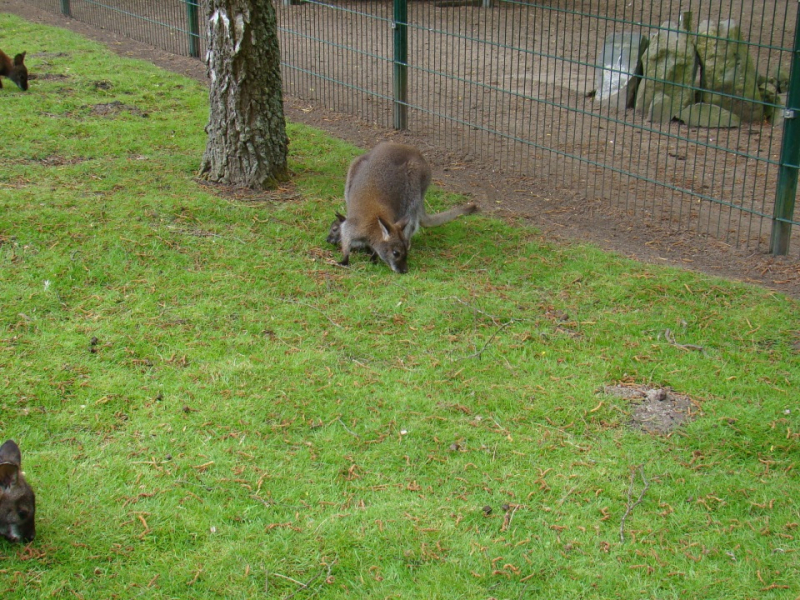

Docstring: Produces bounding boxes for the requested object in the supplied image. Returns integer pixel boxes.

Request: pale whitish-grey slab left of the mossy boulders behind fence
[595,33,649,111]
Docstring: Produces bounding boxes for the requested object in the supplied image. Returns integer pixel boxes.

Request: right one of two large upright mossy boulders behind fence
[695,19,764,121]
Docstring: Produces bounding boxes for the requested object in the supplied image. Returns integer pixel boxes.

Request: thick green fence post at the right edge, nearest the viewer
[769,11,800,255]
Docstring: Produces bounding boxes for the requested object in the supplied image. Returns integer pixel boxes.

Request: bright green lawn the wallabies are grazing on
[0,15,800,600]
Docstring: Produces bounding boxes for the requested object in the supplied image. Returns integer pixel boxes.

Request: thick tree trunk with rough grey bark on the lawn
[200,0,289,189]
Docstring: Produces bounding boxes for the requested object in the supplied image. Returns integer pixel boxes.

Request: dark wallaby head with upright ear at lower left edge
[0,440,36,542]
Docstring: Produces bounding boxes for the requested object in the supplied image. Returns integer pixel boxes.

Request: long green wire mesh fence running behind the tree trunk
[25,0,800,254]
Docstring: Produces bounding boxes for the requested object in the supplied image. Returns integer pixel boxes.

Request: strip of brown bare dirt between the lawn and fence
[0,0,800,298]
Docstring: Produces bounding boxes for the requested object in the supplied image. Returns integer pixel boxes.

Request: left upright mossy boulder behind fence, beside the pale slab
[636,21,697,120]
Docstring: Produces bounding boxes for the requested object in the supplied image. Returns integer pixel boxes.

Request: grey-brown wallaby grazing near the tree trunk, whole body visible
[328,142,478,273]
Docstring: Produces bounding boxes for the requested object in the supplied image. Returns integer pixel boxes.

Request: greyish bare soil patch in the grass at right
[603,385,696,435]
